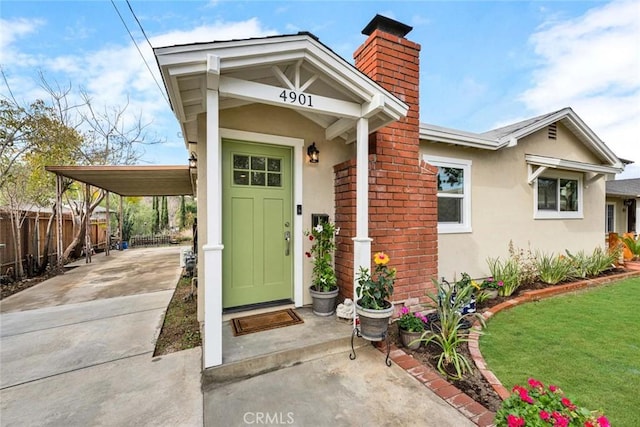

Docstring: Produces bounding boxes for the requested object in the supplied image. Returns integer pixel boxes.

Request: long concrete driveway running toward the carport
[0,247,203,426]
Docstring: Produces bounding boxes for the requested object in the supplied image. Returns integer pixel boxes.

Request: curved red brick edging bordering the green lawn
[468,265,640,400]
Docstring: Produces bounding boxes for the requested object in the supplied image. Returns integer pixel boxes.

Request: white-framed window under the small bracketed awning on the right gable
[534,173,582,219]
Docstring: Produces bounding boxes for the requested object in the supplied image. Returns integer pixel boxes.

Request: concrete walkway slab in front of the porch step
[204,344,474,427]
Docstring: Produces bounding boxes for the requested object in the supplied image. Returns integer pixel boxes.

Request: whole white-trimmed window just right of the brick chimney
[424,156,471,233]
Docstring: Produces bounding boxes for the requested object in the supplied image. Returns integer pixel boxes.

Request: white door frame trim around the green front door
[219,128,304,307]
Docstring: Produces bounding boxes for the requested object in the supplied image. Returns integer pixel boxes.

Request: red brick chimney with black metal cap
[334,15,438,306]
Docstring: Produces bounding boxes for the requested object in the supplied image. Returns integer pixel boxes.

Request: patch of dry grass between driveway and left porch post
[153,277,202,357]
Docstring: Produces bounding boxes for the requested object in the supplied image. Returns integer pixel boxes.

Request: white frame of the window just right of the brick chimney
[422,154,473,234]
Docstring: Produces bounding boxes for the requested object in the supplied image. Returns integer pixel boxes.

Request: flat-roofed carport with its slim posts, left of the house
[45,166,196,266]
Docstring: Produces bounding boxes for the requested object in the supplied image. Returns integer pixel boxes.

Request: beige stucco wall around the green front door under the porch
[198,104,355,310]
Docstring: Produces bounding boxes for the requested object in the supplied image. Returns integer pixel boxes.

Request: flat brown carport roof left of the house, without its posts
[45,165,194,196]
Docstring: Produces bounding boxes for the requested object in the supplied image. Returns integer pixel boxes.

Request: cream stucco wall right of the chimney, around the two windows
[420,124,605,279]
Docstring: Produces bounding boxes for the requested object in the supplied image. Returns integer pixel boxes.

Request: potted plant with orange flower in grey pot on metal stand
[356,252,396,341]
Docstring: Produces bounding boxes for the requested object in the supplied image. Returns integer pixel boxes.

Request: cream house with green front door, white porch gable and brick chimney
[154,15,623,368]
